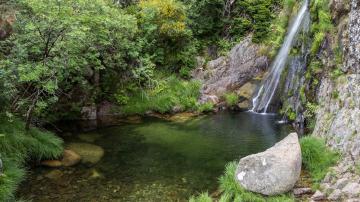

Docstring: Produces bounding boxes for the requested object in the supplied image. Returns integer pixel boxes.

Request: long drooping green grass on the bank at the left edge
[0,116,63,201]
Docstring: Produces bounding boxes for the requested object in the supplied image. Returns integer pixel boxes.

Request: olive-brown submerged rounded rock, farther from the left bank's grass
[67,143,104,164]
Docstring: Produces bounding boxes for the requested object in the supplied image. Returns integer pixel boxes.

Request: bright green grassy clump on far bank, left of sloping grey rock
[120,76,200,114]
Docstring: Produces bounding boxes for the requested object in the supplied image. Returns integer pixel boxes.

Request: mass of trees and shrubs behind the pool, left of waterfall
[0,0,283,128]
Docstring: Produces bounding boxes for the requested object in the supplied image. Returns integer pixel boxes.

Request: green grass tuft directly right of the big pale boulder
[300,136,339,183]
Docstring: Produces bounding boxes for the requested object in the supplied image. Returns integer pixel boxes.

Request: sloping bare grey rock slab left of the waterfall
[193,37,268,104]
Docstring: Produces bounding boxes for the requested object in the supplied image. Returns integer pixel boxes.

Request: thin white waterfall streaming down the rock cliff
[251,0,308,113]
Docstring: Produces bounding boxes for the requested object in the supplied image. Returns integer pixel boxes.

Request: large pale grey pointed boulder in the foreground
[235,133,301,196]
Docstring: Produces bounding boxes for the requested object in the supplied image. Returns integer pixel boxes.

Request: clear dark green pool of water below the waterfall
[19,112,289,201]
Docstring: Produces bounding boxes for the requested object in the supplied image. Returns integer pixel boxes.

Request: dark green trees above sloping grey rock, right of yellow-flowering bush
[184,0,282,43]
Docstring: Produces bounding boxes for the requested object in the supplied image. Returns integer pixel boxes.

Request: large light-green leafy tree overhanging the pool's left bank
[0,0,137,129]
